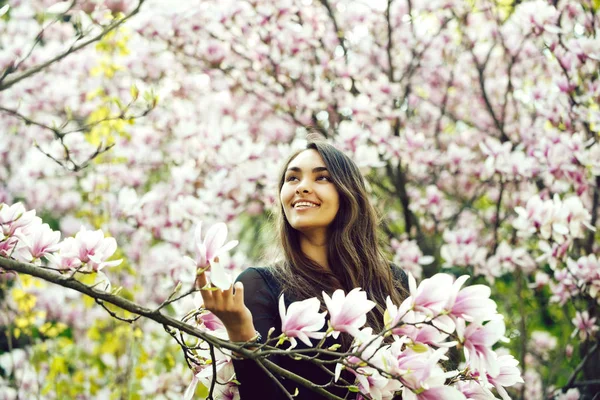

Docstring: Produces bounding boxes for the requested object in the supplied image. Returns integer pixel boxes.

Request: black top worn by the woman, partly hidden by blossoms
[233,265,408,400]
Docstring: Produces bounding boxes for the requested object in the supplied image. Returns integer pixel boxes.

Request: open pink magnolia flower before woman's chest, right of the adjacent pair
[323,288,376,339]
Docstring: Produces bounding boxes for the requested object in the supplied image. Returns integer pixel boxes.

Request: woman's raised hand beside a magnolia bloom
[196,272,256,342]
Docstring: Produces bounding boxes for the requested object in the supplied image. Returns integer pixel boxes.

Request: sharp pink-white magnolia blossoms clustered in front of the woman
[186,260,523,400]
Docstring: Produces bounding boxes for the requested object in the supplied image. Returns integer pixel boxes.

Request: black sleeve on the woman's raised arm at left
[233,268,285,400]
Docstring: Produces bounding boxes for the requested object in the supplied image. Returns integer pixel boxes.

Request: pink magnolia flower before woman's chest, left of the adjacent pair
[279,294,327,348]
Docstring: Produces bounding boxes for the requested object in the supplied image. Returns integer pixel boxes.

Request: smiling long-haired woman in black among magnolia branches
[198,141,408,400]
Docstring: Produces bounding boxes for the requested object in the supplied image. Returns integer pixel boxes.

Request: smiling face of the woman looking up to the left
[279,149,339,238]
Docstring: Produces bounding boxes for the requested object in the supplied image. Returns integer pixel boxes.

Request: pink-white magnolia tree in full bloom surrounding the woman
[0,0,600,399]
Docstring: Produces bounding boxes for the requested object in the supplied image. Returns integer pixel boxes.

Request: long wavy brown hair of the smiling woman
[275,141,406,338]
